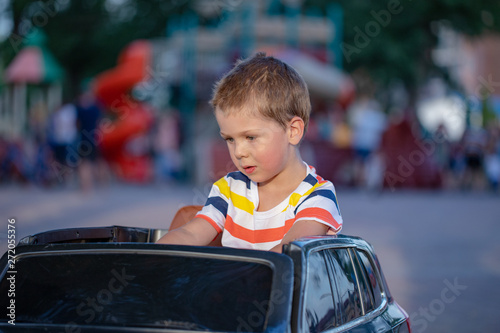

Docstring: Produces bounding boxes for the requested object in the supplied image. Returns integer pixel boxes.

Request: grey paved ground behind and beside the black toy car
[0,185,500,333]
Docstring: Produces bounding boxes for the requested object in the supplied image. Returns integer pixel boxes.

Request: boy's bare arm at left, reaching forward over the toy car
[156,217,217,246]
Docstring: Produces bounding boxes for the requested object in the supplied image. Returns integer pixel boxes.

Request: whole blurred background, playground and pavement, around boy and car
[0,0,500,332]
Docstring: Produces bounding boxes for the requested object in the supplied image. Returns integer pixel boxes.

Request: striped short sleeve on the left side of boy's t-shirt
[195,178,229,233]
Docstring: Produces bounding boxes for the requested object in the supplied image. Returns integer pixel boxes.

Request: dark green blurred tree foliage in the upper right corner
[305,0,500,102]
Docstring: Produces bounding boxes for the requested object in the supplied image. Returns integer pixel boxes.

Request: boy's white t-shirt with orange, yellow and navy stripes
[196,166,342,250]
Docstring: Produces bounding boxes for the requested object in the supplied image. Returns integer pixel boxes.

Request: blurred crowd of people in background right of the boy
[306,96,500,192]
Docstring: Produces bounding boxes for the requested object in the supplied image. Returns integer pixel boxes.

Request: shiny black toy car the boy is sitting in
[0,226,410,332]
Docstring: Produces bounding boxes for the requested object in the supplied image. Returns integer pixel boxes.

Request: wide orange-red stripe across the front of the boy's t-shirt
[224,216,295,244]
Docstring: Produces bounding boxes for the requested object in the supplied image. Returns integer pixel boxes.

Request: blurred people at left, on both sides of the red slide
[0,91,182,192]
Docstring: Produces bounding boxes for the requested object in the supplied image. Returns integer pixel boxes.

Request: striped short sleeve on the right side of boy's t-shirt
[295,182,342,233]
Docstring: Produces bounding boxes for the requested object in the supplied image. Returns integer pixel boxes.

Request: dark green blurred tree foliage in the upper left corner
[1,0,188,95]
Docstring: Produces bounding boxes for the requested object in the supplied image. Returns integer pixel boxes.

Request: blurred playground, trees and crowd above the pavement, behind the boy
[0,0,500,191]
